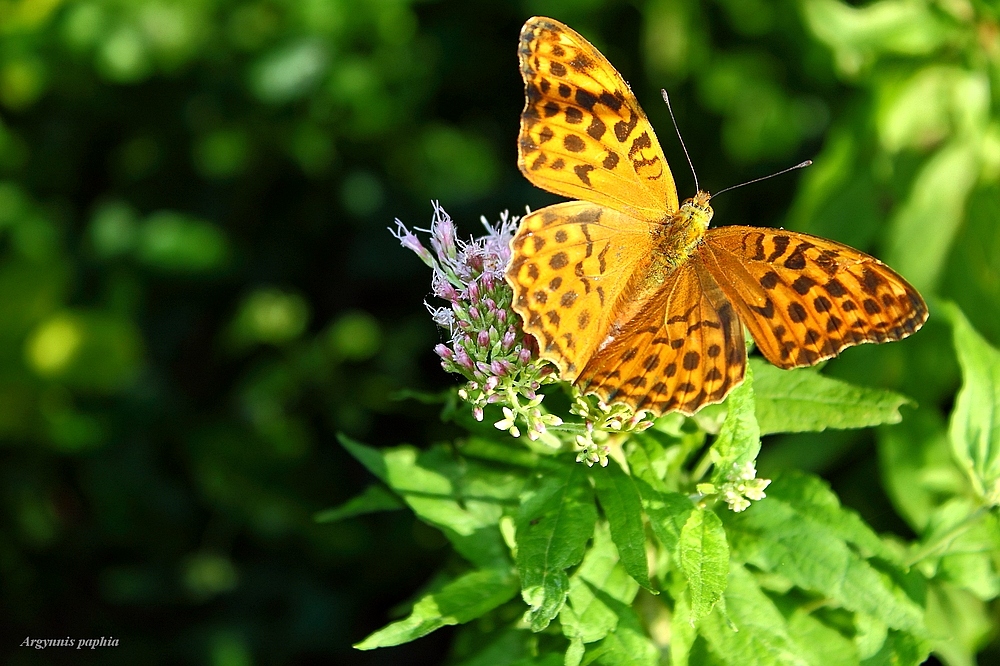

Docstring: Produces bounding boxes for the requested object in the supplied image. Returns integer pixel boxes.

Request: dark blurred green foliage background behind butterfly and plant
[0,0,1000,666]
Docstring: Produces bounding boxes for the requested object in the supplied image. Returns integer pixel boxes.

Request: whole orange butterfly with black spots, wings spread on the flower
[506,17,927,415]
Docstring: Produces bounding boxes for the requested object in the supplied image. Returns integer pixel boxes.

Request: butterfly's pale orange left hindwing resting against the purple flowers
[507,201,651,381]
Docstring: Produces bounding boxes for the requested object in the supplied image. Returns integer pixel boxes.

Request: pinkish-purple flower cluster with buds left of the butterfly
[390,202,562,440]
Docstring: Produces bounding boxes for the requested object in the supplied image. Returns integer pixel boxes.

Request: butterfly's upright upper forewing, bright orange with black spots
[518,17,677,221]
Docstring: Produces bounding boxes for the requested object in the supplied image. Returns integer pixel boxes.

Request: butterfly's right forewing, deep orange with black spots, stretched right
[699,226,927,368]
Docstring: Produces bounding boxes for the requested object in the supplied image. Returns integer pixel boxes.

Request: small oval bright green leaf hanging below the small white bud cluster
[680,508,729,620]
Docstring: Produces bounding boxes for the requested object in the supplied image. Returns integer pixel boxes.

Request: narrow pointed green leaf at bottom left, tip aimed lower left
[354,569,517,650]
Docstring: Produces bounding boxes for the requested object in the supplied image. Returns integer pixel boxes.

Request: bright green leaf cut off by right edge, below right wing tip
[943,303,1000,506]
